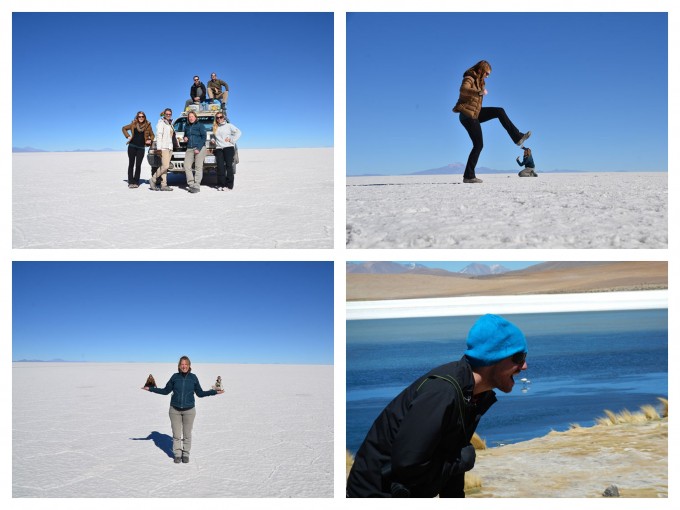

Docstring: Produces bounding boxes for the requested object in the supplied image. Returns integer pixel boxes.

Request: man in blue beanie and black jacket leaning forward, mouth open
[346,314,527,498]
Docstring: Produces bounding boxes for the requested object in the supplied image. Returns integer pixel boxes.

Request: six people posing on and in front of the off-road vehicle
[123,73,241,193]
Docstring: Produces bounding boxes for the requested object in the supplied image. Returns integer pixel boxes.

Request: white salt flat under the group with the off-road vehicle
[12,148,333,248]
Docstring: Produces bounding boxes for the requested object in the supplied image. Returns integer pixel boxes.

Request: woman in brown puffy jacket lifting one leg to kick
[453,60,531,183]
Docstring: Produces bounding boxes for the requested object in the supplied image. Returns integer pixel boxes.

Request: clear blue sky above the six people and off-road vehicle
[12,11,333,150]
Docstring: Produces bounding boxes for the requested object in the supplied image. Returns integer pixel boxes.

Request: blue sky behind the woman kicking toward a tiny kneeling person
[347,13,668,175]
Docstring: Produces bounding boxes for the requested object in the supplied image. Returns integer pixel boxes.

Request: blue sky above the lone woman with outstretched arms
[12,262,333,364]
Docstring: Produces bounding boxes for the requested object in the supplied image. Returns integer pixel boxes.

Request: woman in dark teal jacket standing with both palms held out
[142,356,224,464]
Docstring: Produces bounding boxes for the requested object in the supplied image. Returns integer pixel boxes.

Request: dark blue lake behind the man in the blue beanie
[347,309,668,453]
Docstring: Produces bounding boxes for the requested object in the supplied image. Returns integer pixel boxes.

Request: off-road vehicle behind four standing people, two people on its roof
[146,105,238,178]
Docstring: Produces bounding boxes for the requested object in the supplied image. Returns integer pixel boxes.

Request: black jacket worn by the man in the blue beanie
[347,357,496,497]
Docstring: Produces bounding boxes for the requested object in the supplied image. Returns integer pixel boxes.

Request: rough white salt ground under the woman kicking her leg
[346,172,668,249]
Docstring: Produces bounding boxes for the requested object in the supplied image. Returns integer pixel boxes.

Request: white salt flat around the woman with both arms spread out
[12,363,333,498]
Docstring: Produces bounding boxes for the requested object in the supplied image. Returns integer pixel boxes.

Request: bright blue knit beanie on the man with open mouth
[465,314,527,367]
